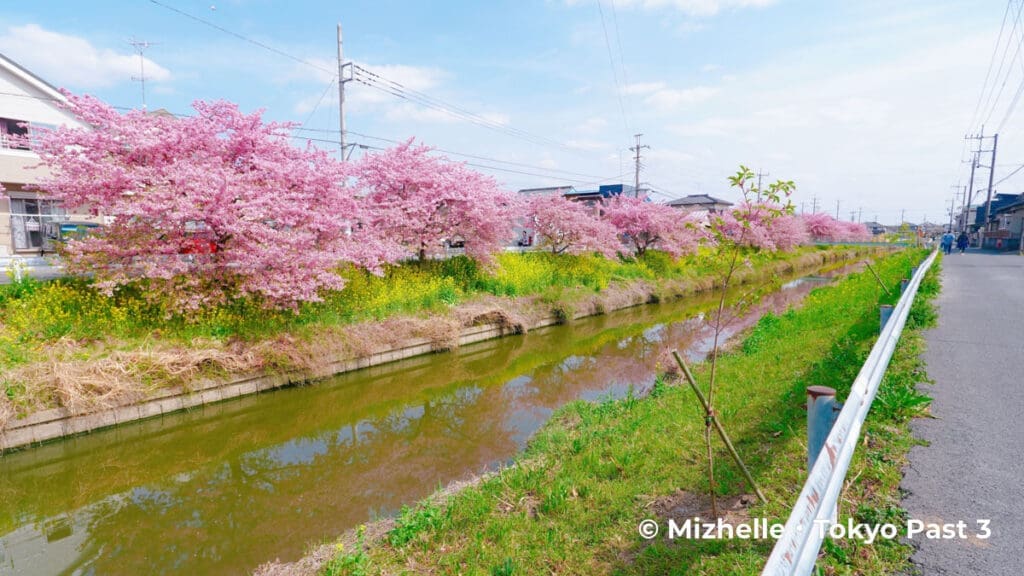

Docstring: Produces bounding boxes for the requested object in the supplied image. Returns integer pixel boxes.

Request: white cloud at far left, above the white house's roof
[0,24,171,89]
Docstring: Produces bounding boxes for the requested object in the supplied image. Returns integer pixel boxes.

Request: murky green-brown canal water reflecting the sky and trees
[0,262,851,576]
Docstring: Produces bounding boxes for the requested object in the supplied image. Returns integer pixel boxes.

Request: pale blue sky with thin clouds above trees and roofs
[0,0,1011,222]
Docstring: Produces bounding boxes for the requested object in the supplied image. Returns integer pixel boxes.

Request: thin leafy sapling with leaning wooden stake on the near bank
[676,166,806,517]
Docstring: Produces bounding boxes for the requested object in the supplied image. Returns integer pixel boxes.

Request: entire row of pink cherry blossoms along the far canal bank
[36,94,869,312]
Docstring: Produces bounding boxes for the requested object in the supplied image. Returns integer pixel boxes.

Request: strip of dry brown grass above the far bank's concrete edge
[0,245,880,429]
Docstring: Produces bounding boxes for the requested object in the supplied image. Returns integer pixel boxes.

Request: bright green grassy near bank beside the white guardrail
[325,247,934,574]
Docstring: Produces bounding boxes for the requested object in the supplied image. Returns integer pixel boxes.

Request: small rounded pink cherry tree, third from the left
[524,194,623,258]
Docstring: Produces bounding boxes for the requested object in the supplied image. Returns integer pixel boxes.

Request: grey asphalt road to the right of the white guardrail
[902,251,1024,576]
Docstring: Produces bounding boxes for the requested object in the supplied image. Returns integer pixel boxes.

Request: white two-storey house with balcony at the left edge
[0,50,88,256]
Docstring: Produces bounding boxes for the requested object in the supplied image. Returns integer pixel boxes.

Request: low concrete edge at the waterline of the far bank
[0,249,869,452]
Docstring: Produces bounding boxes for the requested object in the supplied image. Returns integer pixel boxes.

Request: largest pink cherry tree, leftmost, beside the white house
[30,94,397,312]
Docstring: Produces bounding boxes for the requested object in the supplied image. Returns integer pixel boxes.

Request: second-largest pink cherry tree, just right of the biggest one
[353,139,520,263]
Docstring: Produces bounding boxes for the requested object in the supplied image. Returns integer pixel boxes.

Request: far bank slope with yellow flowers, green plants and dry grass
[0,247,864,414]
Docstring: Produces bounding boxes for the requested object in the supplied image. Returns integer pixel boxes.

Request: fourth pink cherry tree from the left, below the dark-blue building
[604,196,705,257]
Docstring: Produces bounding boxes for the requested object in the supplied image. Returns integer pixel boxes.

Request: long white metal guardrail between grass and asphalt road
[761,248,938,576]
